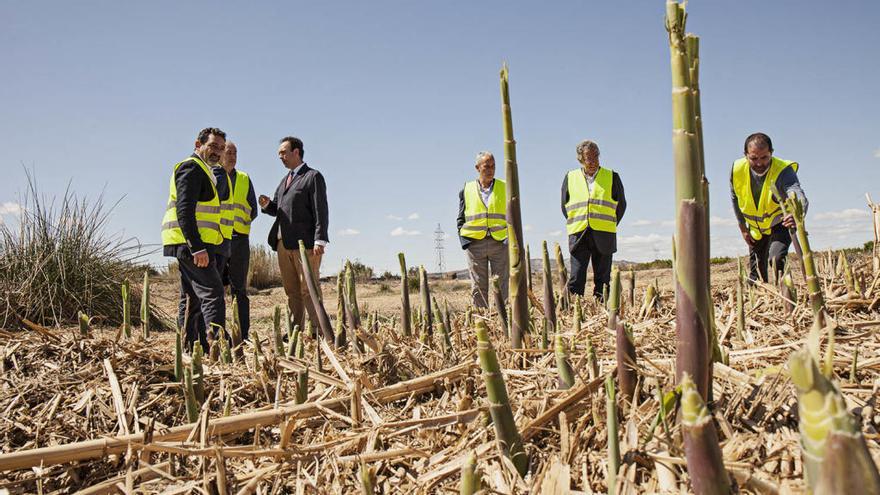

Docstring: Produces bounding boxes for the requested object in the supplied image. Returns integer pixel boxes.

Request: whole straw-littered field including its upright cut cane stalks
[0,2,880,494]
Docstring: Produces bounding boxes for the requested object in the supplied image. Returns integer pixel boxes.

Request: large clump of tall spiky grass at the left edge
[0,173,145,327]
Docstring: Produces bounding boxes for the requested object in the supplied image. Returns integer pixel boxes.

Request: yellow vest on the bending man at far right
[733,156,799,240]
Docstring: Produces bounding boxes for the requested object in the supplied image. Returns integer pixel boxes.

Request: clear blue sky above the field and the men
[0,0,880,273]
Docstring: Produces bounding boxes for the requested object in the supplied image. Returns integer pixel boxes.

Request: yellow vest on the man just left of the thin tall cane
[458,179,507,241]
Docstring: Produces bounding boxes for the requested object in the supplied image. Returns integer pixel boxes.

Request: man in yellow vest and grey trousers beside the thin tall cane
[457,151,509,308]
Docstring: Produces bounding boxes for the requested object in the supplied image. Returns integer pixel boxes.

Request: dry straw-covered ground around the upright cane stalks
[0,254,880,493]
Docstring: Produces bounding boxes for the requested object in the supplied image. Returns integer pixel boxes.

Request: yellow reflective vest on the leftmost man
[162,157,223,246]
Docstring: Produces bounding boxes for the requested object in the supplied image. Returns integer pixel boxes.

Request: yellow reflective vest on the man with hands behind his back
[565,167,617,235]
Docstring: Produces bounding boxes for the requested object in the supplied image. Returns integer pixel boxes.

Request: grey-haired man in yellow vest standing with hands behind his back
[562,140,626,301]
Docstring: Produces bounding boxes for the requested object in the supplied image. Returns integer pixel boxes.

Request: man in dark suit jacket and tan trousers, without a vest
[259,136,330,328]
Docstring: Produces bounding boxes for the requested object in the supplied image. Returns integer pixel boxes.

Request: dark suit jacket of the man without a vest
[263,164,330,250]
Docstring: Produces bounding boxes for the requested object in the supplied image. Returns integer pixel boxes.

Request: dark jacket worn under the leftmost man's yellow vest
[162,153,220,257]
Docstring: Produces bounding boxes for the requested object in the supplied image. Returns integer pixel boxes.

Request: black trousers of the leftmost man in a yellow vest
[177,254,226,353]
